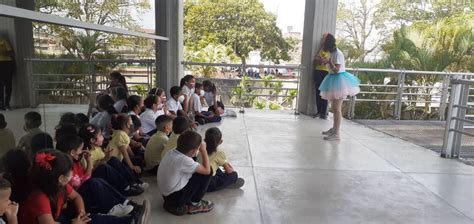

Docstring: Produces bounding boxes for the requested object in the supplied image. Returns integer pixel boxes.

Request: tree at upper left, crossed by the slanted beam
[36,0,150,59]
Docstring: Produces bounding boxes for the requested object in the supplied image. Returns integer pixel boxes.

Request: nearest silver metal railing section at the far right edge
[441,78,474,158]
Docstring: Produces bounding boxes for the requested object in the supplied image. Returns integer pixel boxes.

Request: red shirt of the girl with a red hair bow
[18,185,73,224]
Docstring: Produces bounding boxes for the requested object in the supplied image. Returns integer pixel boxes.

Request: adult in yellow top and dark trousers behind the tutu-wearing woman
[313,33,329,119]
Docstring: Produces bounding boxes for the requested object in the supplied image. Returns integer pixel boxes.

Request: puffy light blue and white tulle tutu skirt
[319,72,360,100]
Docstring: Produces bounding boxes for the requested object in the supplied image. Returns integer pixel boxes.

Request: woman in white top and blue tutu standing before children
[319,34,360,140]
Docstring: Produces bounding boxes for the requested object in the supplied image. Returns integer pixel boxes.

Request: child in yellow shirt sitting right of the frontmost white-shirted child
[198,127,245,192]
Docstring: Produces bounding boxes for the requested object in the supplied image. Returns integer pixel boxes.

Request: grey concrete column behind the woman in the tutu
[298,0,337,115]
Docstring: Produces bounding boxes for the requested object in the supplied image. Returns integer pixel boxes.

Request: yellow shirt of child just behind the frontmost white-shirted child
[145,131,169,169]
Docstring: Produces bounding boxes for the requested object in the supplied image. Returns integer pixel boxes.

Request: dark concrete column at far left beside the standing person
[0,0,36,108]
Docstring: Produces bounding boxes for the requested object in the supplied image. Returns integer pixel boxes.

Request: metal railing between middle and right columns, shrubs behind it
[182,61,303,114]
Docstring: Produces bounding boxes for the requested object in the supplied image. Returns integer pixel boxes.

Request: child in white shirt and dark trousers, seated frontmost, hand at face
[157,131,214,215]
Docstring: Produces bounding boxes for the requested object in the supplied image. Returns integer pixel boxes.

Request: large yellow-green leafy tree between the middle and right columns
[184,0,294,63]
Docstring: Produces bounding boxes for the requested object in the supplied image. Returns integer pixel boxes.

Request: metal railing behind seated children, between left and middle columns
[25,58,155,106]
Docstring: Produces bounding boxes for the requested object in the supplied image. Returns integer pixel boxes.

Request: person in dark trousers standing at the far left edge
[0,36,16,111]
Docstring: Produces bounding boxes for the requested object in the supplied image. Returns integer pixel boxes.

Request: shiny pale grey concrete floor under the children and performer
[0,106,474,224]
